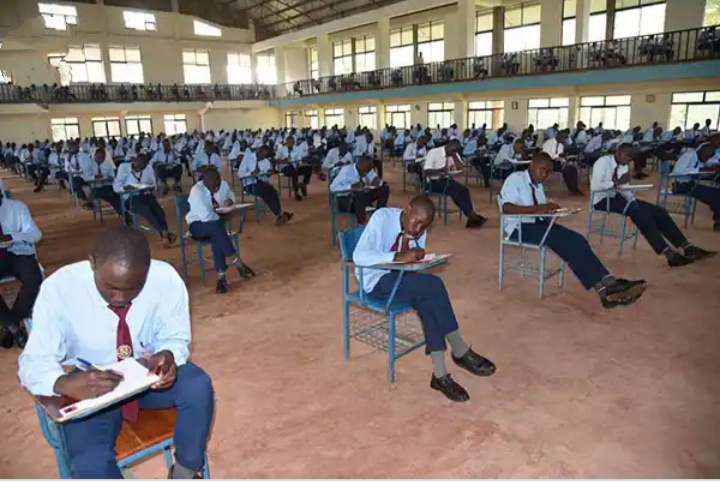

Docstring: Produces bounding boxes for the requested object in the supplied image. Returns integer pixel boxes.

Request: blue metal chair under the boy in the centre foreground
[338,227,425,383]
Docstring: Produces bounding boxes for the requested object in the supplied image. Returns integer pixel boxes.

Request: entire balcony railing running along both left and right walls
[0,26,720,106]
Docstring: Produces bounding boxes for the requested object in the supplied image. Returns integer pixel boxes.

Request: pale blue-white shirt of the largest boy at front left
[19,260,190,396]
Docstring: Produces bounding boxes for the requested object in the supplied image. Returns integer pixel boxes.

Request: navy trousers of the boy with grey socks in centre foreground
[370,271,458,353]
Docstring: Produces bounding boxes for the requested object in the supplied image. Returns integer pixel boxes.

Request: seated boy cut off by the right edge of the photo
[672,142,720,232]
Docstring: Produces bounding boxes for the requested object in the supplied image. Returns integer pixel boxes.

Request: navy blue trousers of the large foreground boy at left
[64,362,214,479]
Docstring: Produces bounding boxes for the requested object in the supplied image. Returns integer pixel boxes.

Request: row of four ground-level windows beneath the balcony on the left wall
[50,114,187,142]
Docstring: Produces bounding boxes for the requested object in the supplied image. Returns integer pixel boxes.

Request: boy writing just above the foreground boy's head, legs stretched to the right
[113,154,177,245]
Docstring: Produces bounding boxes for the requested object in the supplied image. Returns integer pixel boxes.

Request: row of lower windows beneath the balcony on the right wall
[285,91,720,130]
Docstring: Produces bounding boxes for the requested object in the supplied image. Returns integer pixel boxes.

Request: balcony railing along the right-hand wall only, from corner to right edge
[285,26,720,97]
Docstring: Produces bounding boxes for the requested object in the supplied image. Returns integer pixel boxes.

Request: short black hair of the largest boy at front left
[91,225,150,269]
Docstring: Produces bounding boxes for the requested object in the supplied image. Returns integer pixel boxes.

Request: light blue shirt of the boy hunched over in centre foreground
[352,208,427,293]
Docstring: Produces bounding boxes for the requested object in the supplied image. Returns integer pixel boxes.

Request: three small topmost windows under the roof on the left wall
[38,3,222,37]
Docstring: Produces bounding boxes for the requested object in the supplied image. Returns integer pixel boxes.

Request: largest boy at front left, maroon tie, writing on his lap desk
[19,226,214,479]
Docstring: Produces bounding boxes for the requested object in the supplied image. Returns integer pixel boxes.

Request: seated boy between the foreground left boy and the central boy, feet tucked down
[185,168,255,294]
